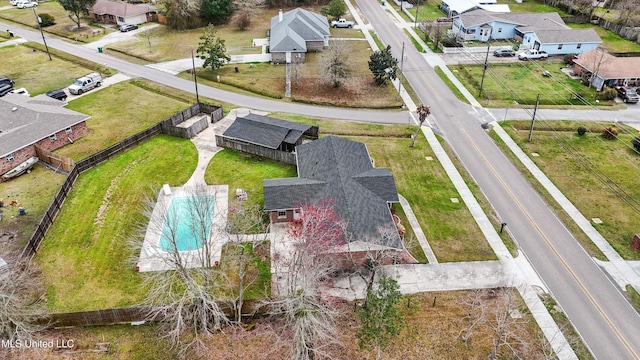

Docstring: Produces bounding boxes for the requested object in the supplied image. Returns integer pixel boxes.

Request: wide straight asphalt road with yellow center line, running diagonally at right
[357,0,640,359]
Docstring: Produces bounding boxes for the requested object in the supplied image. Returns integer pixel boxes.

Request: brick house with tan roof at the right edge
[572,48,640,91]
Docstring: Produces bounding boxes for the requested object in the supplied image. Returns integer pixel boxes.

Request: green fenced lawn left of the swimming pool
[35,135,198,311]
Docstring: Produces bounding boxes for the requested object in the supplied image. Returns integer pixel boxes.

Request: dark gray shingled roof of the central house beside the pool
[264,136,402,248]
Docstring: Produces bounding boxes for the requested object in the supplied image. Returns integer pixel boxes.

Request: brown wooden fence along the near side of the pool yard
[38,300,265,328]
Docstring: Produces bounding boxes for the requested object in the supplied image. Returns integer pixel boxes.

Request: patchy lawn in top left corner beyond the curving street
[0,1,114,43]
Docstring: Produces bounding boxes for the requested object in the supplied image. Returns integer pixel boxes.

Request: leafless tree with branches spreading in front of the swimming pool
[133,186,230,351]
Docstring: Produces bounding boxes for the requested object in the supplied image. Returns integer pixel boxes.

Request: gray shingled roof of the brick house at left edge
[0,94,89,157]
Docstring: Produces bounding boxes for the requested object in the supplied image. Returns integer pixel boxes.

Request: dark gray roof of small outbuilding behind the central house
[223,114,311,149]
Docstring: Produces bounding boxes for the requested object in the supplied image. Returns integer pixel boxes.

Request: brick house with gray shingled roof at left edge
[0,94,89,181]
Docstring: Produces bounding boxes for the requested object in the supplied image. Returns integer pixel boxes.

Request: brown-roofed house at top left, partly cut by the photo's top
[89,0,157,25]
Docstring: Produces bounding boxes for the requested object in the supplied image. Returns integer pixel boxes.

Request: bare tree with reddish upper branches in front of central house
[265,200,346,360]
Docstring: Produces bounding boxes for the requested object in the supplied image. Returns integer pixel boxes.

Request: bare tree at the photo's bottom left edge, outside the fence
[0,243,44,341]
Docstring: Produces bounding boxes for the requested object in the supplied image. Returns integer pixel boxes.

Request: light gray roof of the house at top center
[269,8,330,52]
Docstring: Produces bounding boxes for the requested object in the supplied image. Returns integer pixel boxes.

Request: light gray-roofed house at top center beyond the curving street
[269,8,330,64]
